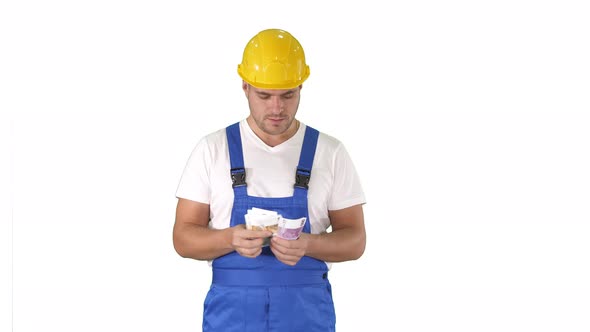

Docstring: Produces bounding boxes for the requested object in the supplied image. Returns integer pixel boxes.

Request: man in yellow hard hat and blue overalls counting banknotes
[173,29,365,332]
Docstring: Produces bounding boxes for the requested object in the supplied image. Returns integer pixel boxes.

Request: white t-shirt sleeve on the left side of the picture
[176,137,211,204]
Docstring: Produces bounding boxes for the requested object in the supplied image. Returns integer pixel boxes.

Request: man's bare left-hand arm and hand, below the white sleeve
[173,198,271,260]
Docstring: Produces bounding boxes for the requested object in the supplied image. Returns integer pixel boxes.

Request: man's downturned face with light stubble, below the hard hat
[242,82,301,138]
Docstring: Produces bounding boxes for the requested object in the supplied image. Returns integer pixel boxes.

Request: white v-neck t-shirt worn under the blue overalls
[176,119,365,234]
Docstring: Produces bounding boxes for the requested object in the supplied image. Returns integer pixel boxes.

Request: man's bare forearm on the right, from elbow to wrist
[302,227,366,262]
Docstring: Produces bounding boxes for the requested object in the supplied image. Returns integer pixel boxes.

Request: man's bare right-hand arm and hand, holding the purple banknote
[271,205,366,265]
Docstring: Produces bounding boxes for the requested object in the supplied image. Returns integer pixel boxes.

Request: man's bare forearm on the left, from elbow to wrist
[173,223,234,260]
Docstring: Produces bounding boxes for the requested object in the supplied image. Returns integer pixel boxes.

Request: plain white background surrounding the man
[0,0,590,332]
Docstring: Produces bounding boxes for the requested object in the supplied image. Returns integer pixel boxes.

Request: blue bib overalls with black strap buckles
[203,123,336,332]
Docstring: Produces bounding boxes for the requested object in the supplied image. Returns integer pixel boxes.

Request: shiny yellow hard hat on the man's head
[238,29,309,89]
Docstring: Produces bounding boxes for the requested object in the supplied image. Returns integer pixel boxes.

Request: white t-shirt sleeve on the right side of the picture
[328,143,366,210]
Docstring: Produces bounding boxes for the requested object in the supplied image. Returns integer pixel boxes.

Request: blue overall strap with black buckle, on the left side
[225,122,246,197]
